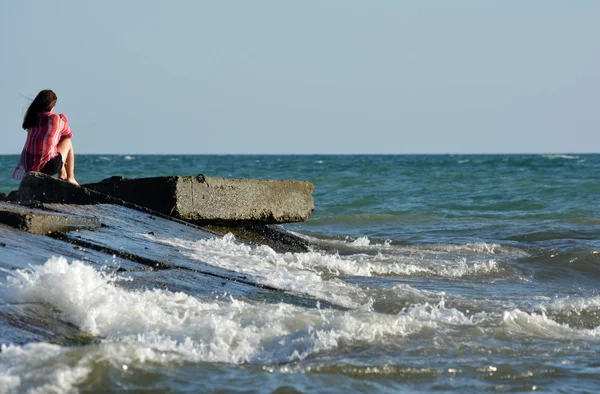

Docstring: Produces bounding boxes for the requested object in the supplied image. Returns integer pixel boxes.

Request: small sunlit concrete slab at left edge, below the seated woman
[0,202,100,234]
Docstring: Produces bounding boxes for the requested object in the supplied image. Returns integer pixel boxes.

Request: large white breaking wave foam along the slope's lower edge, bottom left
[0,258,480,392]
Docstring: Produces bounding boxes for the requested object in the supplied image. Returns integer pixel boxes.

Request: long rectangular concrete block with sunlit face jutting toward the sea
[83,176,314,224]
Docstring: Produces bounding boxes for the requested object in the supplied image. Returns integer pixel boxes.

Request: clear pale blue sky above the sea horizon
[0,0,600,154]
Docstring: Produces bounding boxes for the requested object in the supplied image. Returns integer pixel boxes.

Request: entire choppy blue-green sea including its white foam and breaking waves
[0,154,600,393]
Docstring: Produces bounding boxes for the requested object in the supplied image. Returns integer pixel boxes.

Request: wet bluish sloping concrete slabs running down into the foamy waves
[0,204,343,346]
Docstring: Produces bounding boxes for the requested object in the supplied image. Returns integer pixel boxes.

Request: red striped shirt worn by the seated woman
[13,112,73,179]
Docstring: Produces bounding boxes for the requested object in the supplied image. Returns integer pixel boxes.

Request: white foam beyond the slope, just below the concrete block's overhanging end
[153,234,508,290]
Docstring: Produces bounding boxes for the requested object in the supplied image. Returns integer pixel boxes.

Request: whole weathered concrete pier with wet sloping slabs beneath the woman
[0,173,326,344]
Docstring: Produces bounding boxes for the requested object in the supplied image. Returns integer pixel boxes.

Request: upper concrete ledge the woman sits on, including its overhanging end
[8,172,314,252]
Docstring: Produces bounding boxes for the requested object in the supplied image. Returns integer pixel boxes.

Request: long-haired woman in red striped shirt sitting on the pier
[13,90,79,186]
